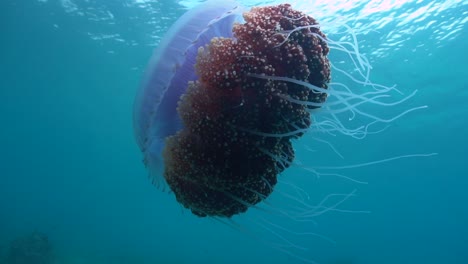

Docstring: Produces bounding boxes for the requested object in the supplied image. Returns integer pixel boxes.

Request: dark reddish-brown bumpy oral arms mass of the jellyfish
[163,4,330,217]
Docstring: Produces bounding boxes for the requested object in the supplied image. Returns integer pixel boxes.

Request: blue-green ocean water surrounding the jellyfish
[0,0,468,264]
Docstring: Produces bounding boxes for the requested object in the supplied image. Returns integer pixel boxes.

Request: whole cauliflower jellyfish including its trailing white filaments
[134,1,434,263]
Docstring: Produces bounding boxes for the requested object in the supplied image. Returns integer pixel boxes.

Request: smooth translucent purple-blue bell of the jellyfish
[133,0,242,185]
